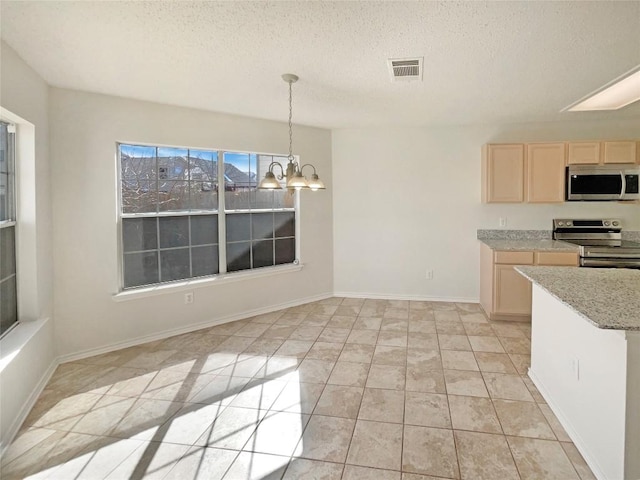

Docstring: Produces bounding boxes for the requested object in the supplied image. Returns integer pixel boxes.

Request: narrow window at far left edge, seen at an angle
[0,122,18,335]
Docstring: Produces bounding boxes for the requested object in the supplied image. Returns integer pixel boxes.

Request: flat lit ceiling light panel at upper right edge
[562,65,640,112]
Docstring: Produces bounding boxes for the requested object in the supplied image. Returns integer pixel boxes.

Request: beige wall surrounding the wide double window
[50,88,333,357]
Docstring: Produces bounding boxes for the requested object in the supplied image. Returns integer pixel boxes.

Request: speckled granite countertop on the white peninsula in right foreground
[515,266,640,330]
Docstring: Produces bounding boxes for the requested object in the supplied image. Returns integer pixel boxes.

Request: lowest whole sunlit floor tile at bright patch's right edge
[243,411,310,456]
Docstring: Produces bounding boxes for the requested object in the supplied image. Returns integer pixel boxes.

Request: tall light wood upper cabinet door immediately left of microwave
[527,143,565,203]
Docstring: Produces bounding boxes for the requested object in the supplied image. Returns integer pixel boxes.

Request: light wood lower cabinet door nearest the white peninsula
[494,265,531,315]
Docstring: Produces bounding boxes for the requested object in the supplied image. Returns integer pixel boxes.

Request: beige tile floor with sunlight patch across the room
[2,298,594,480]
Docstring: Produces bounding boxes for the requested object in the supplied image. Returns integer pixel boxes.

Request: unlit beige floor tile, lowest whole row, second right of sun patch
[347,420,402,470]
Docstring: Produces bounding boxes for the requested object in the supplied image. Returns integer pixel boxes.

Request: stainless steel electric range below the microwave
[553,218,640,269]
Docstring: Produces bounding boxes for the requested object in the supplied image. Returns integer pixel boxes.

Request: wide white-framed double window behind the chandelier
[118,144,296,289]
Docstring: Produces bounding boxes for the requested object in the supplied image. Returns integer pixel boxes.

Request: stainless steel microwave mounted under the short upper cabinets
[567,164,640,201]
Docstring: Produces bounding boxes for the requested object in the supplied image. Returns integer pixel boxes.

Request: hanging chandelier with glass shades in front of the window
[258,73,326,191]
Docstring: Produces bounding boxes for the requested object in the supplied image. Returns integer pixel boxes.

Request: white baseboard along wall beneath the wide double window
[57,293,334,363]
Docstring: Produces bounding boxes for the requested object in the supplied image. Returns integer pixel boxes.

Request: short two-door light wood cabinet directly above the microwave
[567,140,640,165]
